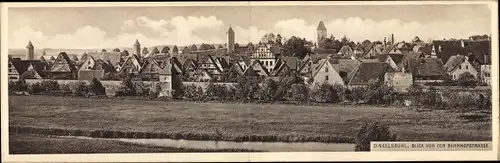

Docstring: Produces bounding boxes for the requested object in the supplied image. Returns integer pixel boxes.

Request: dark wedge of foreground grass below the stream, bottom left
[9,134,264,154]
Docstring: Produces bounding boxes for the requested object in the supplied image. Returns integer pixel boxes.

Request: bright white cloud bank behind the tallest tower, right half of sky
[274,17,490,42]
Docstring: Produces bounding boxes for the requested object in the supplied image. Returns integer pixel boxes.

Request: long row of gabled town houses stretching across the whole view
[9,36,490,93]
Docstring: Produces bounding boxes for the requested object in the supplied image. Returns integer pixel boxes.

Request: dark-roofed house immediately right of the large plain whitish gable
[346,62,392,88]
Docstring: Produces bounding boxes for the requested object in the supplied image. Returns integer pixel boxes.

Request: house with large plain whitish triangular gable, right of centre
[311,59,344,86]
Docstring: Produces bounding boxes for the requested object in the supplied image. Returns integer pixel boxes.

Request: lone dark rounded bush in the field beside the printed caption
[354,122,396,151]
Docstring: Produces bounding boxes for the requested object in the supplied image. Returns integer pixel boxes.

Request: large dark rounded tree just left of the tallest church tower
[282,36,312,58]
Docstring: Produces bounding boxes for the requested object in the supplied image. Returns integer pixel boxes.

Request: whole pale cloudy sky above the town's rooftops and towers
[8,4,491,49]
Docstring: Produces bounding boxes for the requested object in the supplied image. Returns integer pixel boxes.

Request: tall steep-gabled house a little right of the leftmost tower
[50,52,78,79]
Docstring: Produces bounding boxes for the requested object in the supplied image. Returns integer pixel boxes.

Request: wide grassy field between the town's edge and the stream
[9,96,491,141]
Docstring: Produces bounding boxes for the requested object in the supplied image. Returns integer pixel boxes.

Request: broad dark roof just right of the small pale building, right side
[407,58,447,77]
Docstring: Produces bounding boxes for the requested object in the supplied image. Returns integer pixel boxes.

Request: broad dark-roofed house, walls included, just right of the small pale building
[402,58,447,83]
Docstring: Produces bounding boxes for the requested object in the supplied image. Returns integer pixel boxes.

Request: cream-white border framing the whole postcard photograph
[0,1,500,162]
